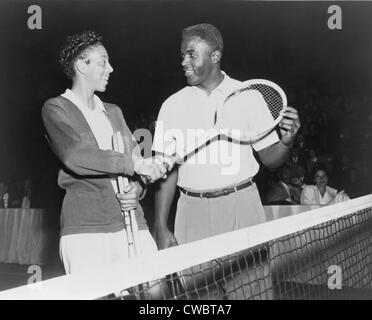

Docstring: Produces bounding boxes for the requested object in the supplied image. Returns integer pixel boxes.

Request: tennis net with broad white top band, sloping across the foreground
[0,195,372,300]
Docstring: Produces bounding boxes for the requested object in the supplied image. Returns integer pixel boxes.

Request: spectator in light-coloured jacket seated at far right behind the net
[300,166,349,205]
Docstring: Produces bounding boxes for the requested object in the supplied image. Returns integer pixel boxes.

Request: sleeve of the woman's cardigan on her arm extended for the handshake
[42,100,134,176]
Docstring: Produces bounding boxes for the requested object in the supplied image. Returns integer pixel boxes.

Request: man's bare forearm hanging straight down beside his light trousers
[155,168,178,230]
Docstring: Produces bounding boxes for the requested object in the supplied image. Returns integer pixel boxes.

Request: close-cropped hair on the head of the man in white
[182,23,223,55]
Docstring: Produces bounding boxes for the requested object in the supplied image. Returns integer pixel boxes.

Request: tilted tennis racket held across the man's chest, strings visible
[164,79,287,164]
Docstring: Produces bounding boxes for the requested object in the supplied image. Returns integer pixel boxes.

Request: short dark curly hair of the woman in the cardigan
[59,31,103,79]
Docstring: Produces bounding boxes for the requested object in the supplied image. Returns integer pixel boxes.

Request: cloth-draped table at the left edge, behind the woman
[0,209,48,265]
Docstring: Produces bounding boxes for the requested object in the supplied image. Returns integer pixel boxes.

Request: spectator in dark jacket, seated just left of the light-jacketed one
[266,165,299,205]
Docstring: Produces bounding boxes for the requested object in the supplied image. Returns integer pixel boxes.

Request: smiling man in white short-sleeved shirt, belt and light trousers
[153,24,300,249]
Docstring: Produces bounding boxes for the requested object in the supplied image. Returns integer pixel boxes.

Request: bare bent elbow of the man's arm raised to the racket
[258,141,291,169]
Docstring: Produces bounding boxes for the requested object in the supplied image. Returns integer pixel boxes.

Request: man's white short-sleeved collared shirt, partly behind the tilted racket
[152,73,279,190]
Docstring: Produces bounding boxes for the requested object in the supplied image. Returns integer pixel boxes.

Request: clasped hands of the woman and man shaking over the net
[134,156,174,183]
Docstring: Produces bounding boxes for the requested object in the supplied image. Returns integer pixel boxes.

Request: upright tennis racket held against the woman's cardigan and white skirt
[112,131,140,258]
